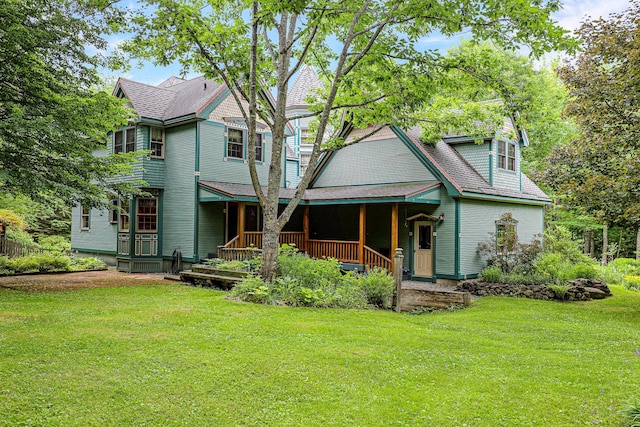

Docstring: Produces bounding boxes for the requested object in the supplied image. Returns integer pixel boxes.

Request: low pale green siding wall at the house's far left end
[71,206,118,252]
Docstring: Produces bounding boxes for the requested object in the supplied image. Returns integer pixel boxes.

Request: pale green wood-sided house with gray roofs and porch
[72,72,549,283]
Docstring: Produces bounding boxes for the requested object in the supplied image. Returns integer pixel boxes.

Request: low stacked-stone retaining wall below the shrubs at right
[455,279,611,301]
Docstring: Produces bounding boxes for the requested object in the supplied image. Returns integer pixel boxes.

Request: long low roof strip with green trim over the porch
[198,181,442,205]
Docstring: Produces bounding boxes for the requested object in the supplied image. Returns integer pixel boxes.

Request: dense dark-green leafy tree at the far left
[0,0,141,206]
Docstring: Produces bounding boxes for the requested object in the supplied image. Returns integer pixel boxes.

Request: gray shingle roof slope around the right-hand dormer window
[405,127,550,202]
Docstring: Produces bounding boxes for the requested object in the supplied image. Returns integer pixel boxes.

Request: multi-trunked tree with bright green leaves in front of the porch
[121,0,573,280]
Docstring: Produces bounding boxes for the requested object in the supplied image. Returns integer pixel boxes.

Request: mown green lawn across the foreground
[0,285,640,426]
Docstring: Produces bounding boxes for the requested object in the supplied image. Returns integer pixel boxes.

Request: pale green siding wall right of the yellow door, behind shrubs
[458,199,544,275]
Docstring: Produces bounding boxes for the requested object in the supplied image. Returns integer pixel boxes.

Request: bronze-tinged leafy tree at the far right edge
[545,0,640,259]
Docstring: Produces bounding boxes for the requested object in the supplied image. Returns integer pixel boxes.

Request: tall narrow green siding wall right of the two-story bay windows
[162,123,196,258]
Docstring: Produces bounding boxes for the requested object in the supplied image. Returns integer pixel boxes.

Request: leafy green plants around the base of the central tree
[230,245,394,308]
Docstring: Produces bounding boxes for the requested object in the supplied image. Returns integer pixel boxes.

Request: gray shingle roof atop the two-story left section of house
[119,77,222,120]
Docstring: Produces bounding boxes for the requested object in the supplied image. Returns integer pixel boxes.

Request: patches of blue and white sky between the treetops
[111,0,629,85]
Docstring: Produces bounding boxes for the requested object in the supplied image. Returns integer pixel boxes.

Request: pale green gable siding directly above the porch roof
[314,138,436,188]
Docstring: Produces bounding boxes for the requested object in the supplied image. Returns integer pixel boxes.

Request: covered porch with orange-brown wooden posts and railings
[201,183,439,271]
